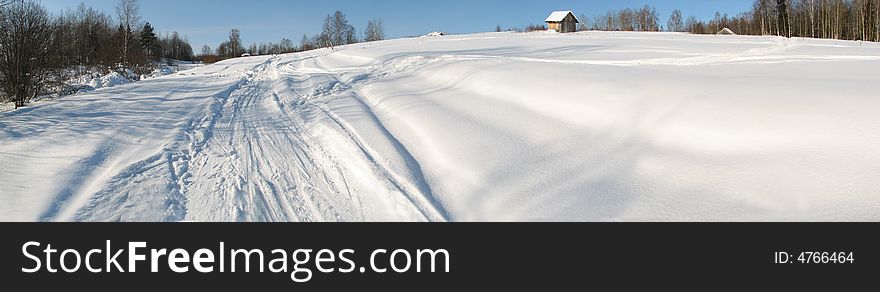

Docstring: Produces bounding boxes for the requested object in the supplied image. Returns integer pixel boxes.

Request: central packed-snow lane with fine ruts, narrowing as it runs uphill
[180,59,359,221]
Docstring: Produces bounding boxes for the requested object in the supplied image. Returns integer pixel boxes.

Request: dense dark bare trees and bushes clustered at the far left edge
[0,0,193,107]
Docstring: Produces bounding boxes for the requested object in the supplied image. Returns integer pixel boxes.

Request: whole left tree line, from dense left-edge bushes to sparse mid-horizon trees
[0,0,385,108]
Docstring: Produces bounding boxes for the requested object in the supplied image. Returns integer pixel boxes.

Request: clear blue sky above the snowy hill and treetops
[42,0,753,52]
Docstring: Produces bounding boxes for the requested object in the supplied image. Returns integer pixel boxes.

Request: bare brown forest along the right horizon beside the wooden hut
[512,0,880,42]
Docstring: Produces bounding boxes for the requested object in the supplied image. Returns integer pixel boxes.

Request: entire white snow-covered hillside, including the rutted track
[0,32,880,221]
